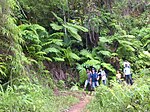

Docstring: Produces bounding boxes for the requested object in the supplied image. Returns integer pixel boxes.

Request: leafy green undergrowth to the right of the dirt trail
[88,76,150,112]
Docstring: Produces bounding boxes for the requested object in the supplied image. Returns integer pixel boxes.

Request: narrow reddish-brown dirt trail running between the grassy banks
[66,95,92,112]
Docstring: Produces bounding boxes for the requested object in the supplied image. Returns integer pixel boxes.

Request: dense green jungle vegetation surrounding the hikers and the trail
[0,0,150,112]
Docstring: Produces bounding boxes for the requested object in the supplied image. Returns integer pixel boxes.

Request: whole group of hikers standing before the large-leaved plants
[84,61,133,90]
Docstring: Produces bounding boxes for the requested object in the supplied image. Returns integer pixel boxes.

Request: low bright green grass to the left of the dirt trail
[0,79,78,112]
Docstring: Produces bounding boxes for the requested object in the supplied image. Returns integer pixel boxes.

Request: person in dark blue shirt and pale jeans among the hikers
[90,68,99,89]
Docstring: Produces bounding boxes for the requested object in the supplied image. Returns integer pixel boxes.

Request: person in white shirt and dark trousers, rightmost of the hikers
[123,64,133,85]
